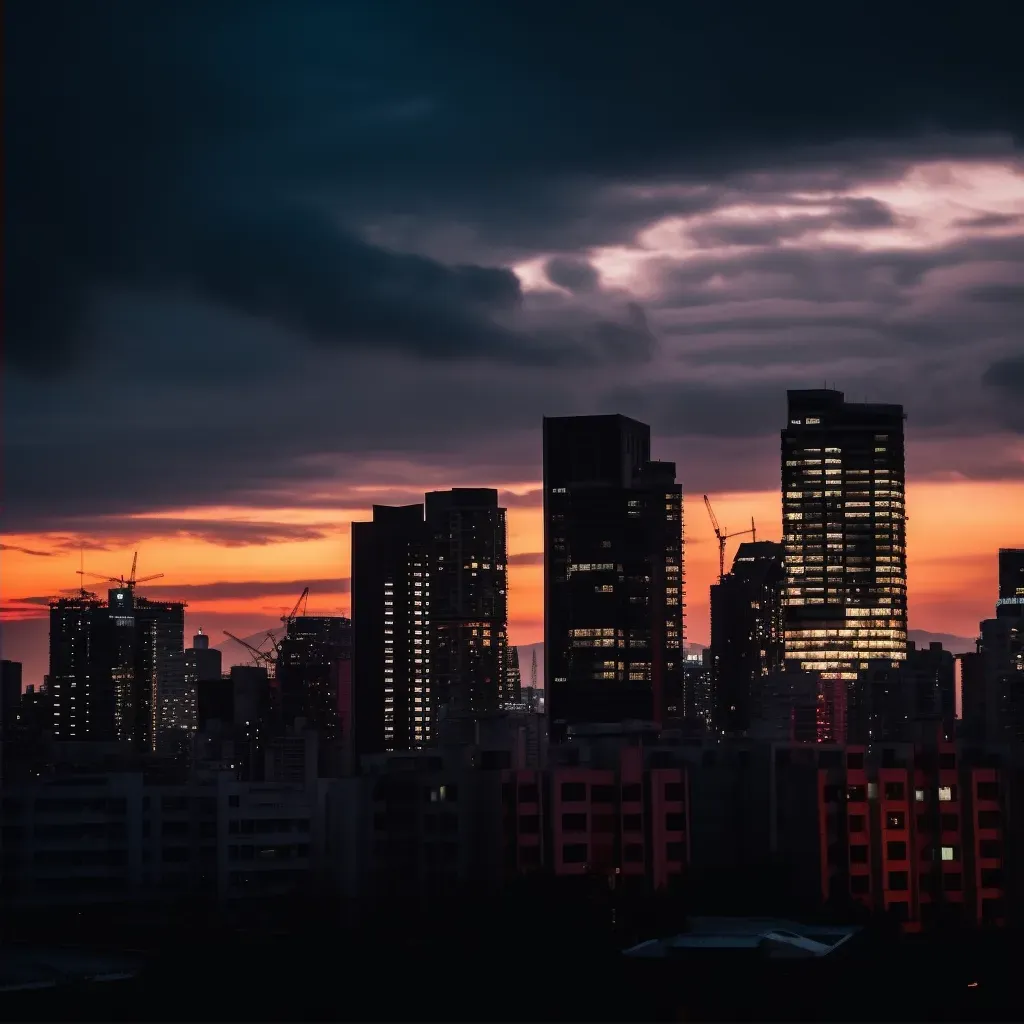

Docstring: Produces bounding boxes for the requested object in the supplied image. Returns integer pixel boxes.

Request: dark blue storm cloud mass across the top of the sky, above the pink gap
[4,0,1021,369]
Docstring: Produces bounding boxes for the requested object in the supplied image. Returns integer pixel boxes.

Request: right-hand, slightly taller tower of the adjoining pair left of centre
[426,487,508,718]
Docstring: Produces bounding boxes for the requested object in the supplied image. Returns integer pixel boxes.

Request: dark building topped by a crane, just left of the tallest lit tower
[711,541,785,733]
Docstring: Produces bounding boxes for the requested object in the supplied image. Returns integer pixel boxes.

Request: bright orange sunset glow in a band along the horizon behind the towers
[6,473,1024,682]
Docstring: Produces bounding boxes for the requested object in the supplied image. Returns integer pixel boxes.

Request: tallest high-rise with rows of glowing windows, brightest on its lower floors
[782,390,906,688]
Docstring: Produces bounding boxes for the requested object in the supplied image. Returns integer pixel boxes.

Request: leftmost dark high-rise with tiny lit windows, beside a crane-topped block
[48,591,117,742]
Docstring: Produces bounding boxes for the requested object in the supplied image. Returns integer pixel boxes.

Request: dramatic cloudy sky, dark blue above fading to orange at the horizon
[0,0,1024,682]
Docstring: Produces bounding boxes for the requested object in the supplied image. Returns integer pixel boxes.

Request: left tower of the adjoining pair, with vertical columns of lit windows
[351,505,435,755]
